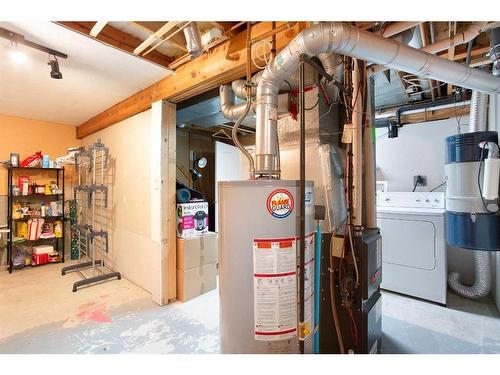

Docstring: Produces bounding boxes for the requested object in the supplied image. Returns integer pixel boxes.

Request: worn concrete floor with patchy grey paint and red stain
[0,265,500,353]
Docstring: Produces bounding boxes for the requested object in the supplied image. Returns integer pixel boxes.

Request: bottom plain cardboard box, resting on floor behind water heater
[177,263,217,302]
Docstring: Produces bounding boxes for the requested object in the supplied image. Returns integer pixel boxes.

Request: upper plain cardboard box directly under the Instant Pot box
[177,232,219,271]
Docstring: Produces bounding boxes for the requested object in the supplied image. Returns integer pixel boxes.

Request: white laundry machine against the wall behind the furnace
[377,192,447,305]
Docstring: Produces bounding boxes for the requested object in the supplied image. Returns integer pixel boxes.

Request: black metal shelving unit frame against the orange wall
[7,166,66,273]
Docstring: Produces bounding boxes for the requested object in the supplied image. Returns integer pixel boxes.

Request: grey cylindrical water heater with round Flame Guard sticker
[219,179,314,353]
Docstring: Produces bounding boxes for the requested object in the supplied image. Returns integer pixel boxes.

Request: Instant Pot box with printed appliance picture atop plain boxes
[176,202,208,238]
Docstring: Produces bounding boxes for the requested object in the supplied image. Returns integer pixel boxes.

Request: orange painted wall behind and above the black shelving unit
[0,114,81,195]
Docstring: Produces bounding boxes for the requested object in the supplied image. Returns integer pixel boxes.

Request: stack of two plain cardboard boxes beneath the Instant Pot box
[177,232,218,302]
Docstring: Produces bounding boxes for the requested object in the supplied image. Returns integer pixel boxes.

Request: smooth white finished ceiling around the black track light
[0,22,170,126]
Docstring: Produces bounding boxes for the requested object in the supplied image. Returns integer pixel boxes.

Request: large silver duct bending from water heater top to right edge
[256,22,500,175]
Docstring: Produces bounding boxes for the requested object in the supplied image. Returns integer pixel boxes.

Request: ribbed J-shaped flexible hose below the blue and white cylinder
[448,250,491,299]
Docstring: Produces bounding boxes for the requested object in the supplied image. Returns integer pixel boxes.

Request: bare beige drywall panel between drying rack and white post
[82,110,157,292]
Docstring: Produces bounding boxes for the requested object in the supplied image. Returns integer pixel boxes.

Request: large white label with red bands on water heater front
[253,237,297,341]
